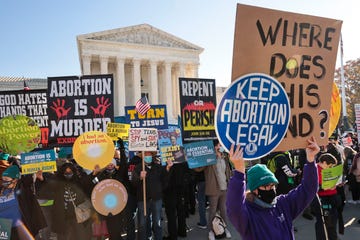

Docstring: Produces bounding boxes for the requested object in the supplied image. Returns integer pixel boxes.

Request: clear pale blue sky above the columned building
[0,0,360,86]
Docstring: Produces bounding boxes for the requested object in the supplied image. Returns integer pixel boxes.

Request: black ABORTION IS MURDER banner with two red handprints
[47,75,114,146]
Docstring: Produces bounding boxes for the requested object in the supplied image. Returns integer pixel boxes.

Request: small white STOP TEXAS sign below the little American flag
[129,128,158,151]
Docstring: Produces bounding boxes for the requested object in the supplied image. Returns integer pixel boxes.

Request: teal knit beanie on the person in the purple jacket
[247,164,279,191]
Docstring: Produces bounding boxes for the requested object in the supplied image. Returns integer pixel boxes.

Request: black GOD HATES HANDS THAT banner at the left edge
[0,89,49,146]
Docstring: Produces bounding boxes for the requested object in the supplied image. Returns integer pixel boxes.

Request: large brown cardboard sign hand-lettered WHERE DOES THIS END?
[232,4,342,151]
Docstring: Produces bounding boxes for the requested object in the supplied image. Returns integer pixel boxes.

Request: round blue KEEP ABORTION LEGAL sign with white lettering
[215,73,290,160]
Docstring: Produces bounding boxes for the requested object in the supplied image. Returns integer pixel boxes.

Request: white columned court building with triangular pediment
[77,24,204,122]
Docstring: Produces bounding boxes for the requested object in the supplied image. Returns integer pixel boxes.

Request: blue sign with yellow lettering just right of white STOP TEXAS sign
[158,127,186,165]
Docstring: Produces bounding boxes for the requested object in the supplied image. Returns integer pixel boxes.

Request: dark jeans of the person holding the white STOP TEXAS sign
[138,199,162,240]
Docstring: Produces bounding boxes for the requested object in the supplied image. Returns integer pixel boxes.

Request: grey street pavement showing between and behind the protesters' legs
[172,191,360,240]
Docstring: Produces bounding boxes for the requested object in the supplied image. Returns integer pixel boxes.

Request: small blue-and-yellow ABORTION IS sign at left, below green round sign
[20,150,56,174]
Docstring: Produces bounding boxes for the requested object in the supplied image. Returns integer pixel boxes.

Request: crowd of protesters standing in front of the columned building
[0,131,360,240]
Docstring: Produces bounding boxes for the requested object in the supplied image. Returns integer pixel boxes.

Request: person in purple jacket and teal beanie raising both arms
[226,137,320,240]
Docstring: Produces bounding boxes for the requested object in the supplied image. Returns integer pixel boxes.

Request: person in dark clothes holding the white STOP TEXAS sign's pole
[131,151,173,240]
